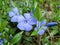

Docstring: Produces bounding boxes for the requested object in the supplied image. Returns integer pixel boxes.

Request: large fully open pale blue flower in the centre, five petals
[17,13,37,32]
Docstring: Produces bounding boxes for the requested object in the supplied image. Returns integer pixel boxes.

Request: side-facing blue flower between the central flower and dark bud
[35,20,47,35]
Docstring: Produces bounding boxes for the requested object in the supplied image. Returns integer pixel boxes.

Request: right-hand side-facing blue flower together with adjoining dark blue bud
[35,20,58,35]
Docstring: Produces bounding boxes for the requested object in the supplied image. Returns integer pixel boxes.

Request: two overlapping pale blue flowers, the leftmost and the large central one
[9,7,37,31]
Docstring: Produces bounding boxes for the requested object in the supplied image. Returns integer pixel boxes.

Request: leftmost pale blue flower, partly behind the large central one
[9,7,19,22]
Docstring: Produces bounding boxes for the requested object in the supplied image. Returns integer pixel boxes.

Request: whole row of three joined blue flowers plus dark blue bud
[9,7,57,35]
